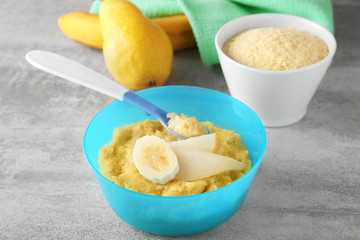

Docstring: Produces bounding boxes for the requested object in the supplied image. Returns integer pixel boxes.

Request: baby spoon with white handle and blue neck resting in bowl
[25,50,201,139]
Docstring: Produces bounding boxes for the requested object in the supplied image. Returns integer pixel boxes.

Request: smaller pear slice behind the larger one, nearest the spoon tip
[168,133,216,152]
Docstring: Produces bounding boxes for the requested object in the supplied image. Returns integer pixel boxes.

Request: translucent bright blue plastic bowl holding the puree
[84,86,266,236]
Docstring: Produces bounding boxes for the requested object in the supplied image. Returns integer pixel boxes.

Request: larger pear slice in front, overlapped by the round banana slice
[173,148,244,181]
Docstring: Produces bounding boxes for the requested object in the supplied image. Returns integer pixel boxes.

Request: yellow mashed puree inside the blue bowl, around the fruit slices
[99,120,251,196]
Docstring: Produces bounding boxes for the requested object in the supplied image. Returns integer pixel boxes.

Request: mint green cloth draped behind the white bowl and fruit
[90,0,334,65]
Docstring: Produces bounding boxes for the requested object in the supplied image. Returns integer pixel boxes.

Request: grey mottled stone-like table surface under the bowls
[0,0,360,239]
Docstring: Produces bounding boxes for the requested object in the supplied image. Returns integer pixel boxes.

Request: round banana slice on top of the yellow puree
[132,136,179,184]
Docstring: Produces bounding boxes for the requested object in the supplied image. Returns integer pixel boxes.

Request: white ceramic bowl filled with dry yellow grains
[215,14,336,127]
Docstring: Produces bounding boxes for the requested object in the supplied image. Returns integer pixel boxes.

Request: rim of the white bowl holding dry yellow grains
[215,13,337,74]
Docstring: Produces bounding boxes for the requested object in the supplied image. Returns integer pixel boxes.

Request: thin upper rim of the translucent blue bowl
[83,85,267,199]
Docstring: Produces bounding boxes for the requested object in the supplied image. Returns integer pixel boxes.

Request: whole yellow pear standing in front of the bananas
[99,0,173,90]
